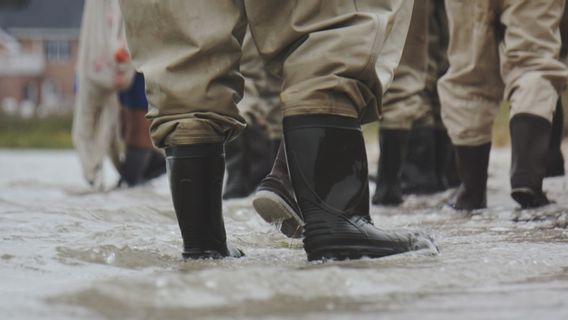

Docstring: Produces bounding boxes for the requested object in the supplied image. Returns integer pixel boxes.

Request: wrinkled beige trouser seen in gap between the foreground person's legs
[237,30,282,139]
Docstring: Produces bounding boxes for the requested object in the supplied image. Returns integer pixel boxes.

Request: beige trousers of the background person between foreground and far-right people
[381,0,447,130]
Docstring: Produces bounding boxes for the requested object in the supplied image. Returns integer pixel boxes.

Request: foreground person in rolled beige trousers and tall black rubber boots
[121,0,427,260]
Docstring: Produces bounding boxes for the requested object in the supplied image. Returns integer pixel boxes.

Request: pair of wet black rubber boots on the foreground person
[166,115,433,260]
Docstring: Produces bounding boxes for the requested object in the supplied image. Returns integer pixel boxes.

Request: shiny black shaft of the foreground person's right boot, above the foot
[284,115,369,223]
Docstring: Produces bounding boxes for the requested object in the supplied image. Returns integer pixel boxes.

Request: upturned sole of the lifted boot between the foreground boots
[252,190,304,238]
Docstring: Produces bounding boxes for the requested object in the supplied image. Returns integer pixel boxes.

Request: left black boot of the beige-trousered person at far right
[448,143,491,210]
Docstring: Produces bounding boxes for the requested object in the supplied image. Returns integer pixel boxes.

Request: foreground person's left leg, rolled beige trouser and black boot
[120,0,246,258]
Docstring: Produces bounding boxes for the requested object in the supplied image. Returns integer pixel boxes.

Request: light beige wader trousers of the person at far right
[438,0,568,146]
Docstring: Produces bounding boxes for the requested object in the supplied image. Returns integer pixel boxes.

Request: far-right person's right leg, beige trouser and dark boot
[501,0,568,208]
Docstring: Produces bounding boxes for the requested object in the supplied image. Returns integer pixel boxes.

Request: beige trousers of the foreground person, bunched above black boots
[120,0,413,147]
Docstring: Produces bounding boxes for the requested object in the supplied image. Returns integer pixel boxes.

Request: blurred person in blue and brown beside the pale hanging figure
[119,70,166,187]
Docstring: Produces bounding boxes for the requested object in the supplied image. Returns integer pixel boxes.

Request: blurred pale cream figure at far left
[72,0,134,189]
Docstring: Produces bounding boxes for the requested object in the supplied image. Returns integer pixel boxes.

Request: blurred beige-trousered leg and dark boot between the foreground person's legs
[223,30,276,199]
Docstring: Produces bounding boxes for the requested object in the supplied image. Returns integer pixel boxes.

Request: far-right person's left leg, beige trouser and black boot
[438,0,503,210]
